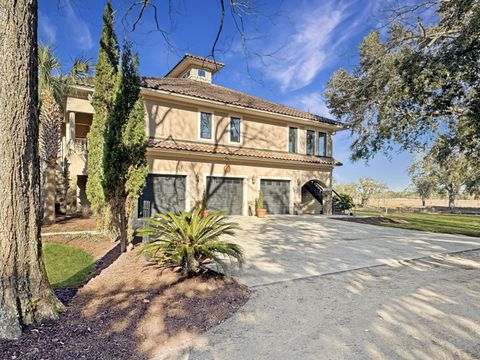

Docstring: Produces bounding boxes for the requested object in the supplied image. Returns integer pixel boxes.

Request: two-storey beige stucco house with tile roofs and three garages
[62,54,343,217]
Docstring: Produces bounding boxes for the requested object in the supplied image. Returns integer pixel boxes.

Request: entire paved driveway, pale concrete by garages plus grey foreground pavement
[153,216,480,360]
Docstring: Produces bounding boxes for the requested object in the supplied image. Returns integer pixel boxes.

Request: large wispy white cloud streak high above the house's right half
[264,0,376,91]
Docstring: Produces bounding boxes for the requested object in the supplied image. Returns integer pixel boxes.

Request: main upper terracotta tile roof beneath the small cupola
[77,77,343,126]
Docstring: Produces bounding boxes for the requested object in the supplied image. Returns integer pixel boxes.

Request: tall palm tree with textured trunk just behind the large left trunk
[38,45,90,223]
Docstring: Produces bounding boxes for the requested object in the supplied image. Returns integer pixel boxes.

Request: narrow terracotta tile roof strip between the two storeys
[148,139,342,166]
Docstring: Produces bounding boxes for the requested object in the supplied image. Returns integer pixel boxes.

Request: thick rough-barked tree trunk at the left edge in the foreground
[0,0,63,339]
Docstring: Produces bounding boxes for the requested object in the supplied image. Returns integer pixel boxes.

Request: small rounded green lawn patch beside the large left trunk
[43,243,95,288]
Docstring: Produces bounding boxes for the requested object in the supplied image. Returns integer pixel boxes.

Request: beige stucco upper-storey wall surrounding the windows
[145,98,332,156]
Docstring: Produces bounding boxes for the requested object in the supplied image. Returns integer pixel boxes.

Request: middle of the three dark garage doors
[207,176,243,215]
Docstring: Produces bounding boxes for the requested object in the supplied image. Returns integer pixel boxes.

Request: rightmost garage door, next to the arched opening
[260,179,290,214]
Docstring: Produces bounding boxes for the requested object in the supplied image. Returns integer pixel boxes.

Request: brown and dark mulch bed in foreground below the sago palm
[0,252,250,360]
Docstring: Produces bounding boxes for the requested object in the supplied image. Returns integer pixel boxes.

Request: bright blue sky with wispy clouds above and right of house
[39,0,411,190]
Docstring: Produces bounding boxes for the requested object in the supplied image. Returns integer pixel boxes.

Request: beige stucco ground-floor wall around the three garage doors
[148,150,331,215]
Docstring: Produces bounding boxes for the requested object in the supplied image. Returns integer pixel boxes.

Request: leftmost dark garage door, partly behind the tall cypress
[138,174,187,217]
